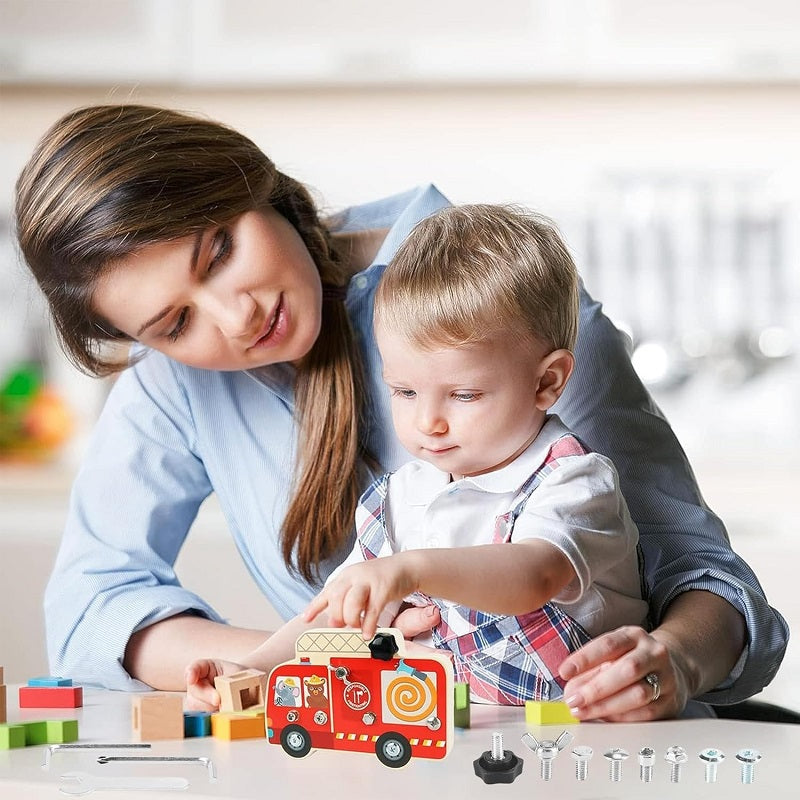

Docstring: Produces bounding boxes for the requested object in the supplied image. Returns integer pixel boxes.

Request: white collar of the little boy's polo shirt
[408,415,569,505]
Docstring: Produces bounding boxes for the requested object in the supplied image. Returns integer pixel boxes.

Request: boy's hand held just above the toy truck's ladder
[303,551,417,640]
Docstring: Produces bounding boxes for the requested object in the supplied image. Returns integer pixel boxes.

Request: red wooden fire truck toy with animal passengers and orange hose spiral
[266,628,453,767]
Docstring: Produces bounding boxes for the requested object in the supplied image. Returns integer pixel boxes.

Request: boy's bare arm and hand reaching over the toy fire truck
[303,539,576,639]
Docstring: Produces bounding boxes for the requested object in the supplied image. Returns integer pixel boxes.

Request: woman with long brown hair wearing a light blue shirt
[16,106,787,720]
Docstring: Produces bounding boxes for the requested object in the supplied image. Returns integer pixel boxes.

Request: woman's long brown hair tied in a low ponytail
[16,105,368,582]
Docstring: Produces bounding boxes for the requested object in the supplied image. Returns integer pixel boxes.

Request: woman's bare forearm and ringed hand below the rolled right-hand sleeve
[560,590,745,722]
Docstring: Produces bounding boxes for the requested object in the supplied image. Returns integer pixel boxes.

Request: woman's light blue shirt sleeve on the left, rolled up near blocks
[45,356,221,691]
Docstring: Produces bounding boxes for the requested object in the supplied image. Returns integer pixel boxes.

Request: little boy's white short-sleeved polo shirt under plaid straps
[329,416,647,636]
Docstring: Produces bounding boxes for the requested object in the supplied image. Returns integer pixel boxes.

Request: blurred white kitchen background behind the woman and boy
[0,0,800,709]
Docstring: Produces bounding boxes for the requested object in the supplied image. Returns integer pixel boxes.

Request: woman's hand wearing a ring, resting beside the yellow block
[559,625,691,722]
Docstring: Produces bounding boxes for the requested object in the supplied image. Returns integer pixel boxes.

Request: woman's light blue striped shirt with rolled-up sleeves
[45,186,788,703]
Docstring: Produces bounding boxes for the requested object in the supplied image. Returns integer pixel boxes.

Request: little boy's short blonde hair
[375,205,578,350]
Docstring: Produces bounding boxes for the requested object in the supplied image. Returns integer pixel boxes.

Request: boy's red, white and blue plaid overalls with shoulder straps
[358,434,589,705]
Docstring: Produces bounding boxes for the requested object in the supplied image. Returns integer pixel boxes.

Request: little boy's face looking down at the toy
[375,325,546,480]
